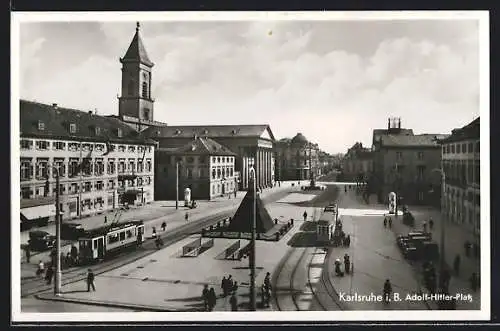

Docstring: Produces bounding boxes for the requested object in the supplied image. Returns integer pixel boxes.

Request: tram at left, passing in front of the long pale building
[78,221,144,264]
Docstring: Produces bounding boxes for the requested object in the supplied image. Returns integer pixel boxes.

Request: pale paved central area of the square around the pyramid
[34,204,312,311]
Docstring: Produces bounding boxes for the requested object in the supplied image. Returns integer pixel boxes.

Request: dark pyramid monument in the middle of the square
[226,184,274,233]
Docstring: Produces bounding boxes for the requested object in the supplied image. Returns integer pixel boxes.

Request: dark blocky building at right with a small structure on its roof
[369,119,446,204]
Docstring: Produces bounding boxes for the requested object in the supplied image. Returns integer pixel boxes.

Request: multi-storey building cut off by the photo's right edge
[441,117,481,234]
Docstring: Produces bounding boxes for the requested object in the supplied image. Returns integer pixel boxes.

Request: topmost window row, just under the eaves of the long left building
[20,139,151,153]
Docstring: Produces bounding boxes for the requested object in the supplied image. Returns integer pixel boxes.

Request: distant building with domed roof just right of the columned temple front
[275,132,322,180]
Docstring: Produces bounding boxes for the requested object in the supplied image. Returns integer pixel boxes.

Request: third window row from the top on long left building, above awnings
[21,176,152,199]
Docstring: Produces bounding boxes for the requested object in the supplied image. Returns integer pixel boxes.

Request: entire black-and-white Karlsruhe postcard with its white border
[11,11,490,322]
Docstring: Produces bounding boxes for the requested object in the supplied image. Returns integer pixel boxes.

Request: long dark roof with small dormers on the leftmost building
[19,100,154,145]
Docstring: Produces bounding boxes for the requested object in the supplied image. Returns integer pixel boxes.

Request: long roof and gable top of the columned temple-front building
[143,124,275,141]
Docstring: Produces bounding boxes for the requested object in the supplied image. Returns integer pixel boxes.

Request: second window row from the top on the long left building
[20,158,152,181]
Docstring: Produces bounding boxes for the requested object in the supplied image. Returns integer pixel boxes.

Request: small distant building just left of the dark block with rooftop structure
[341,142,373,182]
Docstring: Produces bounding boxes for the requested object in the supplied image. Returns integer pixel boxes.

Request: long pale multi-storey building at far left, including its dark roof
[20,100,155,226]
